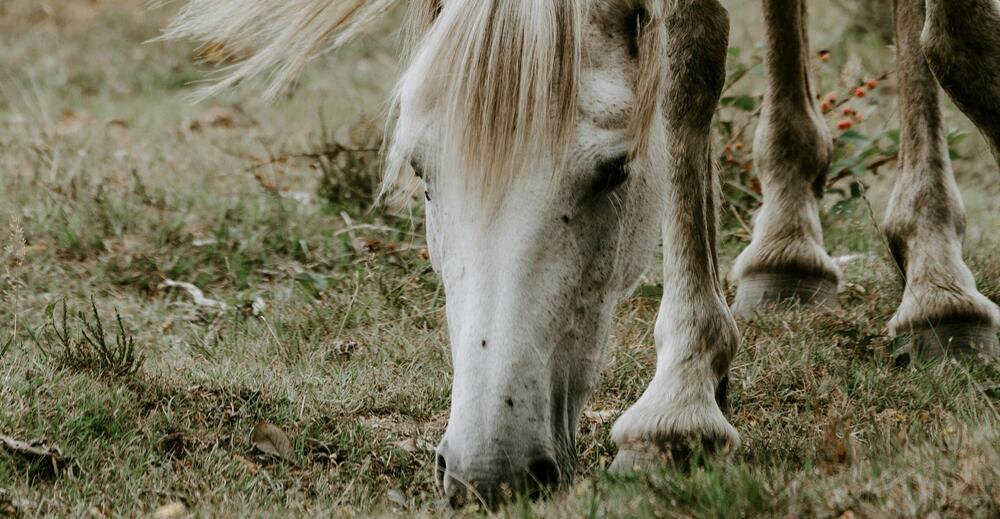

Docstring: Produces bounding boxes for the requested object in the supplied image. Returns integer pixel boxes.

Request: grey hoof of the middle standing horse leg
[732,273,840,317]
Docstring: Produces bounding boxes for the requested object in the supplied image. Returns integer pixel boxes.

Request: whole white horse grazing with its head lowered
[168,0,1000,501]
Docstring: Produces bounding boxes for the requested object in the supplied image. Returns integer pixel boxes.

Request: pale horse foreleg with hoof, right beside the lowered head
[612,0,739,470]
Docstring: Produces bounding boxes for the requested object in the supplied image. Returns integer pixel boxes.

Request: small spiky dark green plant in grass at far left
[35,299,146,378]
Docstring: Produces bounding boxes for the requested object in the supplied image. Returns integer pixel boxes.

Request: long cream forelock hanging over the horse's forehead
[404,0,589,199]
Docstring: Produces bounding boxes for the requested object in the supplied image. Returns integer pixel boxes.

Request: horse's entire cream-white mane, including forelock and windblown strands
[165,0,665,200]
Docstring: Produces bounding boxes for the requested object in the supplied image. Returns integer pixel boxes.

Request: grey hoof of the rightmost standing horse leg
[893,323,1000,367]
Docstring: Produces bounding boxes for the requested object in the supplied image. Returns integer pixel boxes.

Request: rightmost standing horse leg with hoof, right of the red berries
[885,0,1000,364]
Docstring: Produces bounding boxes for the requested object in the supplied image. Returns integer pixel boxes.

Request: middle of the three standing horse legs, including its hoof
[730,0,840,316]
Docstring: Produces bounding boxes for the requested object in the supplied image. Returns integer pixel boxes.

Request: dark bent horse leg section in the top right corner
[914,0,1000,167]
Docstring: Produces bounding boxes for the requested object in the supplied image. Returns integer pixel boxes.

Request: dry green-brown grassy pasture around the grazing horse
[0,0,1000,518]
